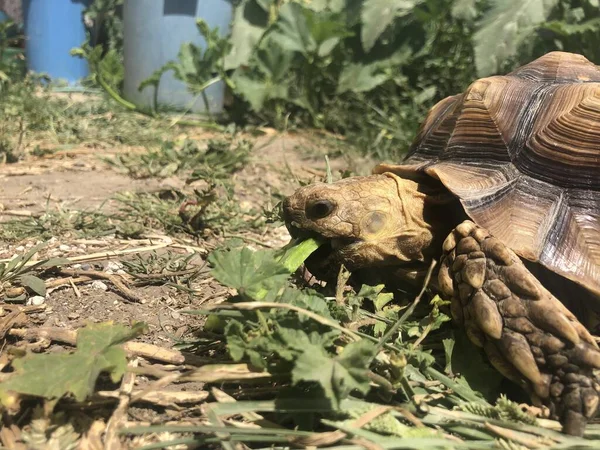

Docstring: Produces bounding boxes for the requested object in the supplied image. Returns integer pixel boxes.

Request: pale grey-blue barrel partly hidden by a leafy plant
[123,0,233,114]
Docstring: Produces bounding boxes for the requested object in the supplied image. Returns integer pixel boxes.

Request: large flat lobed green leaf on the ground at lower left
[0,323,145,401]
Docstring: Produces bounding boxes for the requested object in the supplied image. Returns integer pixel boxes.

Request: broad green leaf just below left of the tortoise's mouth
[208,247,290,300]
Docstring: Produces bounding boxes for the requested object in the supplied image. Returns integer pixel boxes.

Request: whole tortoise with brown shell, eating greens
[283,52,600,435]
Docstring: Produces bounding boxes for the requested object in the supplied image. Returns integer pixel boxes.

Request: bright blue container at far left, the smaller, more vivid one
[23,0,91,84]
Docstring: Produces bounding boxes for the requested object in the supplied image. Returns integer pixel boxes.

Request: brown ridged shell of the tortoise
[374,52,600,295]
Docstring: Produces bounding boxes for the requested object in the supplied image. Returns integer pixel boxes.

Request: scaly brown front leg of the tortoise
[438,221,600,436]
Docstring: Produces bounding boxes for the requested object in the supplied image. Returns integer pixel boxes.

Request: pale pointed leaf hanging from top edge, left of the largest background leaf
[360,0,421,52]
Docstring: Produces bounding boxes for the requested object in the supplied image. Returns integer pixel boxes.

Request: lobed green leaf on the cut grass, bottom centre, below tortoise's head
[292,340,375,409]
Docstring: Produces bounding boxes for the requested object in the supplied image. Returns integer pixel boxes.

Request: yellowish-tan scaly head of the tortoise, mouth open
[283,173,440,277]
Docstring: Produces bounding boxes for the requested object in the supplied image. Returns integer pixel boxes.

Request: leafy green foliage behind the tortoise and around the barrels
[83,0,600,159]
